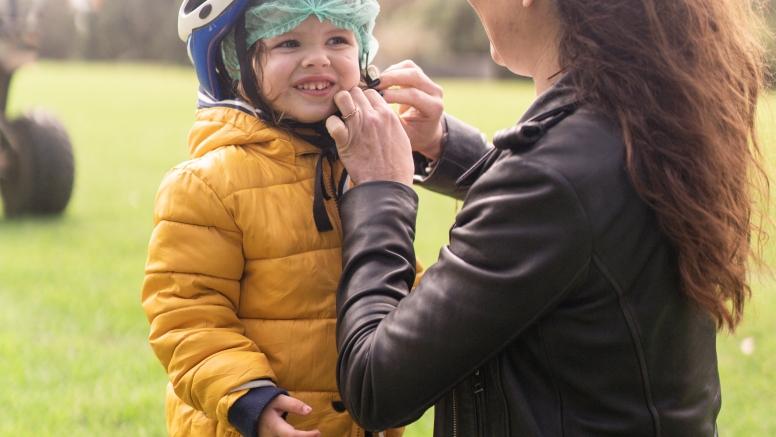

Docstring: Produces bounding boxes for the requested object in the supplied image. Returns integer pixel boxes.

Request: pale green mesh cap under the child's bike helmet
[221,0,380,80]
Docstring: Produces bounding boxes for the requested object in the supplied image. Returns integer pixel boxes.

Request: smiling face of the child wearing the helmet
[260,15,361,123]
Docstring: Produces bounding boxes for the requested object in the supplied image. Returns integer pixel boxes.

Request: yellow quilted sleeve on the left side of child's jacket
[142,166,274,428]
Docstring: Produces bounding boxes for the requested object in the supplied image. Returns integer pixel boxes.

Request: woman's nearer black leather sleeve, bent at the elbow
[337,153,592,431]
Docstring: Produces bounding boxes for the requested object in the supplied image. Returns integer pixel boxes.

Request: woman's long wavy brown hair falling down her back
[554,0,769,331]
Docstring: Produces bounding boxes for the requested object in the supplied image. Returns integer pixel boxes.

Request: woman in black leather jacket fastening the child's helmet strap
[327,0,767,436]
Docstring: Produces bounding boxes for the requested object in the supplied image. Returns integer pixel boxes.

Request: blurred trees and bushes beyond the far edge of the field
[31,0,776,77]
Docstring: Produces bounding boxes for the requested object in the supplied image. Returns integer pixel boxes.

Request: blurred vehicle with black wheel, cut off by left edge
[0,0,75,217]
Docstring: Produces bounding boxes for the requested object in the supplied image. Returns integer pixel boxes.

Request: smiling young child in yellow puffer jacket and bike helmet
[142,0,418,437]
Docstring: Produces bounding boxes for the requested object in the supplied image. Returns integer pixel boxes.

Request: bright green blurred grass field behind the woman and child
[0,63,776,437]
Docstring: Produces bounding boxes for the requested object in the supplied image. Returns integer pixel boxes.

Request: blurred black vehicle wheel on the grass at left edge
[0,111,75,217]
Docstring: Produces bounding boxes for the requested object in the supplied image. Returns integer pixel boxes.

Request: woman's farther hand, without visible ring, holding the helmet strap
[376,61,445,160]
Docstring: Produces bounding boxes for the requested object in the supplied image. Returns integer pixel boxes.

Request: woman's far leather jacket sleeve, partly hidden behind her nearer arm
[413,114,493,200]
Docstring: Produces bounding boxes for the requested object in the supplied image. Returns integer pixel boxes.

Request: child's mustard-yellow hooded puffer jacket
[142,108,416,437]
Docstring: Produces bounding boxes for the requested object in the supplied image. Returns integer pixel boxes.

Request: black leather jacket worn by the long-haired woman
[337,84,720,437]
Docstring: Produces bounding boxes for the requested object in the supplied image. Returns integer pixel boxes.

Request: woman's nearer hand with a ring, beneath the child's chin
[326,87,415,185]
